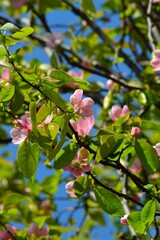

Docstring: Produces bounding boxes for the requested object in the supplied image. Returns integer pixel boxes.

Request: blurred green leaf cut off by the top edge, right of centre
[82,0,96,20]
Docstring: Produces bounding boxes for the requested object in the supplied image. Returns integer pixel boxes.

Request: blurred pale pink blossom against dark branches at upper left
[46,32,64,48]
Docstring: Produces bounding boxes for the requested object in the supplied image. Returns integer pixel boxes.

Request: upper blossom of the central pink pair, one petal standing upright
[70,89,94,117]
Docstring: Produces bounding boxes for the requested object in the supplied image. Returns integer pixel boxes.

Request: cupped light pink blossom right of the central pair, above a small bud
[109,105,129,121]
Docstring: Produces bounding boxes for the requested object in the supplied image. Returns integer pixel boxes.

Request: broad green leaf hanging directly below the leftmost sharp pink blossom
[17,140,40,178]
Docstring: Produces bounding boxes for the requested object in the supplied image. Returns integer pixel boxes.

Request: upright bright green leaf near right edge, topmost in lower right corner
[141,199,156,225]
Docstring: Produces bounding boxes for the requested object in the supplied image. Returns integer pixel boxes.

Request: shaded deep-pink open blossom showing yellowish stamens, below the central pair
[64,147,92,177]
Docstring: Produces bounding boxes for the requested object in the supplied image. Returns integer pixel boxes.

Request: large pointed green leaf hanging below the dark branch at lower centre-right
[94,186,124,217]
